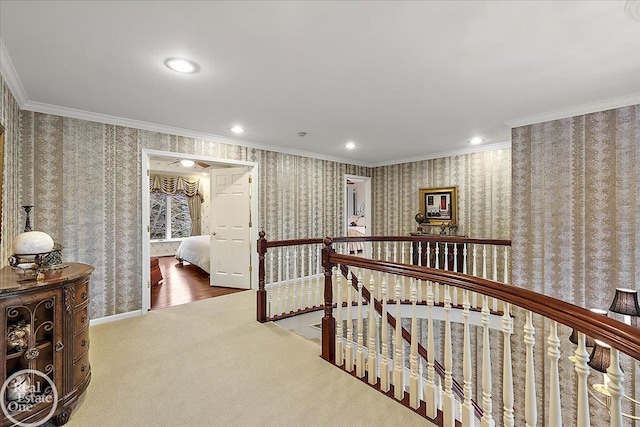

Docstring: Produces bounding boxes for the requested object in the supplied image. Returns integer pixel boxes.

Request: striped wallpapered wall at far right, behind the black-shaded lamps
[512,105,640,425]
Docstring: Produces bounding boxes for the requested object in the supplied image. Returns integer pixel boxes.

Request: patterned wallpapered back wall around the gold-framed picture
[372,149,511,239]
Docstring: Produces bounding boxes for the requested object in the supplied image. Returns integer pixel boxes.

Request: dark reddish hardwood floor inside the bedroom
[151,256,244,310]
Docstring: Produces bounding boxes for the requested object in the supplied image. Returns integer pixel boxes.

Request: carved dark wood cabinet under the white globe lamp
[0,263,94,427]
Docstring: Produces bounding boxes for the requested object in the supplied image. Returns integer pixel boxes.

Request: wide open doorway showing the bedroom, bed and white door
[141,150,258,313]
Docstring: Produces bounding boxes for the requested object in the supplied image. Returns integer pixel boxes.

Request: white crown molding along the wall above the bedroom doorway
[21,101,371,167]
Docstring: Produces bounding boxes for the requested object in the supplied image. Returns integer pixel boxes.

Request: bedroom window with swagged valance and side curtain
[149,175,203,240]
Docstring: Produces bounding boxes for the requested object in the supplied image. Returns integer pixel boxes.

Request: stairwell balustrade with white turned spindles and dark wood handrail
[258,236,640,427]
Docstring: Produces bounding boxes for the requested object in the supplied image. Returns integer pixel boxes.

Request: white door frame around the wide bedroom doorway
[140,148,260,315]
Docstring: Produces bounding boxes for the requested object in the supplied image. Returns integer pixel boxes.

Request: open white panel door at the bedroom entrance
[209,167,251,289]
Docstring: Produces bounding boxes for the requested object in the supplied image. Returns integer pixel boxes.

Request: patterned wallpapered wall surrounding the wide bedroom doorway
[19,111,371,318]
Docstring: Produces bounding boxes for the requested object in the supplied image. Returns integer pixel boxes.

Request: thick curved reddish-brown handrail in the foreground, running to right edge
[329,253,640,360]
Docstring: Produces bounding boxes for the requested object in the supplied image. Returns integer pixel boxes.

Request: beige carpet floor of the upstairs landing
[62,291,432,427]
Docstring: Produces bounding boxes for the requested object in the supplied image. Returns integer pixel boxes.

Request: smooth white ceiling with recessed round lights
[0,0,640,165]
